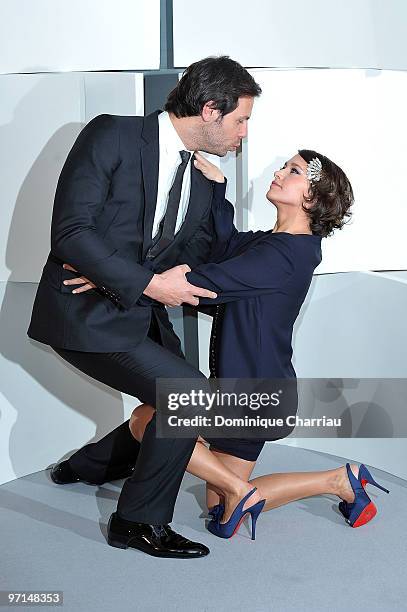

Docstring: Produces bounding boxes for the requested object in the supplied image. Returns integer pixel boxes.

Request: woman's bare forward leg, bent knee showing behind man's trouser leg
[129,404,261,522]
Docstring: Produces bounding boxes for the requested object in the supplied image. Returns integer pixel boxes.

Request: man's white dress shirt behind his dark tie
[151,111,193,238]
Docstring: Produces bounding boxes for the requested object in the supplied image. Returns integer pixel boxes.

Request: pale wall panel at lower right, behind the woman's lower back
[283,272,407,479]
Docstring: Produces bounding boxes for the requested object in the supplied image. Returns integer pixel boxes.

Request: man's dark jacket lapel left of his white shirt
[141,111,161,259]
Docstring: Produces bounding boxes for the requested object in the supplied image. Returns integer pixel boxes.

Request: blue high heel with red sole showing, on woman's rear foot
[339,463,390,527]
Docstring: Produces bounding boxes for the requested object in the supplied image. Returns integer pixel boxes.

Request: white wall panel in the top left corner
[0,0,160,73]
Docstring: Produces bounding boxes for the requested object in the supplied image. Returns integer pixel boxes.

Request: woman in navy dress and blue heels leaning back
[125,150,388,538]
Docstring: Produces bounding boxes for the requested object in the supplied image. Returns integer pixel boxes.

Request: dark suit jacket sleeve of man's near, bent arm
[51,115,153,308]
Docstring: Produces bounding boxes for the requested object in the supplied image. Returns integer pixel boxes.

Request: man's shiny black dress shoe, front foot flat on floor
[107,512,209,559]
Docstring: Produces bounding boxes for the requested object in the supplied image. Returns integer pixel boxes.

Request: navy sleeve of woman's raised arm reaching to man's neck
[209,179,266,262]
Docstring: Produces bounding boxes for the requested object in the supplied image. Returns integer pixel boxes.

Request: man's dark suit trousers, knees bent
[53,322,205,525]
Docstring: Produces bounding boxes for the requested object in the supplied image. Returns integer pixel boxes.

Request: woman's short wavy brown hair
[298,149,354,237]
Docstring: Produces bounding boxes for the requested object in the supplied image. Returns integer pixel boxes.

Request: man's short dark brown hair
[164,55,261,117]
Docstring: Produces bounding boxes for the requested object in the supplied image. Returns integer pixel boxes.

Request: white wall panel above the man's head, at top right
[174,0,407,70]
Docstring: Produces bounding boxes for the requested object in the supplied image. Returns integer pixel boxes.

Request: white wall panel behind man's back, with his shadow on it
[0,72,144,282]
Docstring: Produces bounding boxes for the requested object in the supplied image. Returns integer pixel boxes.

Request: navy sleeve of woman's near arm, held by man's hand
[186,233,294,304]
